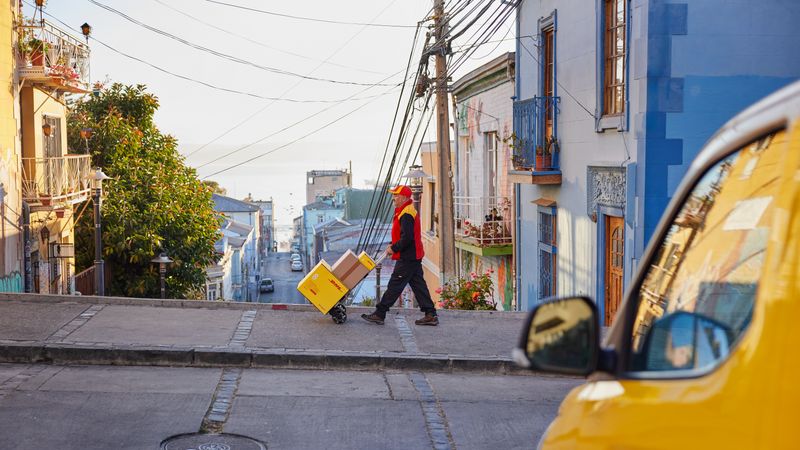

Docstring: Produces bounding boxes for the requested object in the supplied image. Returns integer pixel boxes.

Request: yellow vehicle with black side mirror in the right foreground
[514,82,800,450]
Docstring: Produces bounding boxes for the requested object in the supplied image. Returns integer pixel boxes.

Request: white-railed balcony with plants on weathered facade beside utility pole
[453,196,512,256]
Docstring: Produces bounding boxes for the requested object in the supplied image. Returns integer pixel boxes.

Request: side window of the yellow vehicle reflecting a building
[628,131,786,376]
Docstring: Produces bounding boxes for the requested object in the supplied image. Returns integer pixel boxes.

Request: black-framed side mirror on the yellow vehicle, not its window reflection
[514,297,600,376]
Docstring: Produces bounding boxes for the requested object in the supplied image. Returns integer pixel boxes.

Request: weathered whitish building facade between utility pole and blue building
[452,53,515,310]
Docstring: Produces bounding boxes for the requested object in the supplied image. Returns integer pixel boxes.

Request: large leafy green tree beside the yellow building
[67,83,220,298]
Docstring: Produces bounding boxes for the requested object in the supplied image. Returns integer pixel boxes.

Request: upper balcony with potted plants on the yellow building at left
[18,21,89,93]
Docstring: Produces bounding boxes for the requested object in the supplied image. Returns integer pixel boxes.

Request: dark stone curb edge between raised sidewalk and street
[0,344,535,375]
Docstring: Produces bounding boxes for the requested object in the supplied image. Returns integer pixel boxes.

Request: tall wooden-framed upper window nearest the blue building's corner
[603,0,627,116]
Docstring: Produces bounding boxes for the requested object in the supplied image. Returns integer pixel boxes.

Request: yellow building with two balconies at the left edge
[0,1,91,293]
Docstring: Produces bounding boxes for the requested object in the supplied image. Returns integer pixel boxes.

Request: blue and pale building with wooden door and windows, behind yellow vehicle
[510,0,800,324]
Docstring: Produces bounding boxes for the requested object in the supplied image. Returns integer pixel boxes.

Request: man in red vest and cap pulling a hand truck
[361,186,439,326]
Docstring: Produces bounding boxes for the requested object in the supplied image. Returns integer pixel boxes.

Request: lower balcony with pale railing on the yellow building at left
[22,155,91,211]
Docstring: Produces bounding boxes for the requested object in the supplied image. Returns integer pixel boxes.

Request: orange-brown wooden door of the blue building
[604,216,625,326]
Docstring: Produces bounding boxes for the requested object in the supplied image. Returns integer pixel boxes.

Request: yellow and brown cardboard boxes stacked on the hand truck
[297,250,375,314]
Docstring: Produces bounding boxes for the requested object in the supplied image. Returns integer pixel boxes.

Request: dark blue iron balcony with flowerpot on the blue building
[509,97,561,184]
